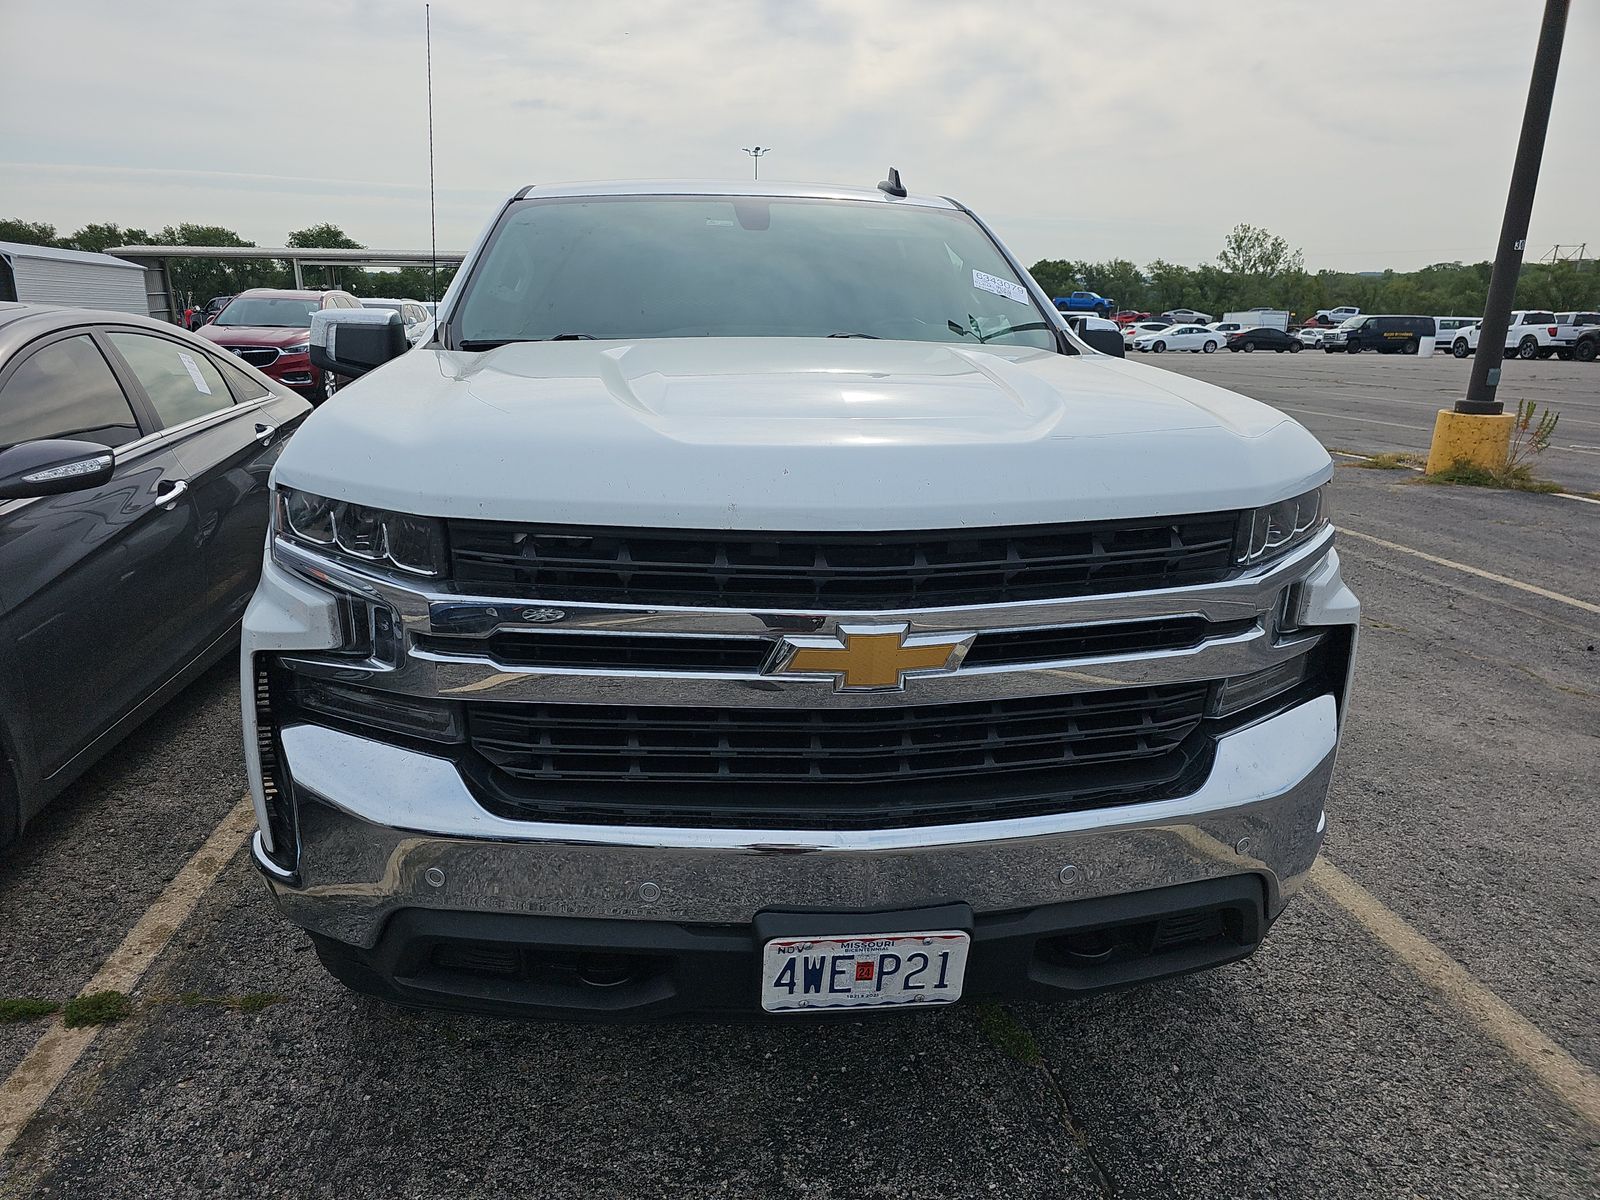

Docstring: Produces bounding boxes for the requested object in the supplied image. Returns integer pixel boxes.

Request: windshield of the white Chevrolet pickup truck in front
[453,197,1056,349]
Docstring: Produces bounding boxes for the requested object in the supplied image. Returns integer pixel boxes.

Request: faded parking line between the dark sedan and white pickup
[0,795,256,1155]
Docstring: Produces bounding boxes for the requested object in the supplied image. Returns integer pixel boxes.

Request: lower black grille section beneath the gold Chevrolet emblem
[466,683,1210,826]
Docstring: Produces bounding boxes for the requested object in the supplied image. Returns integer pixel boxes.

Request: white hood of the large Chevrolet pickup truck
[275,338,1331,530]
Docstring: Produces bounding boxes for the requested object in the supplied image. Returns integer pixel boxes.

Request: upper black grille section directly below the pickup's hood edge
[450,512,1238,611]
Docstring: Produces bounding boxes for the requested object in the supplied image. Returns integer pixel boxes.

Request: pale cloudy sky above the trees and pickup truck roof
[0,0,1600,270]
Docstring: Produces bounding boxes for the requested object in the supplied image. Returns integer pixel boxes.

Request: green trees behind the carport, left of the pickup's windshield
[0,219,456,307]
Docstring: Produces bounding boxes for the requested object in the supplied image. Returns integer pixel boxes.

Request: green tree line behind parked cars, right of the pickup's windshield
[1032,226,1600,320]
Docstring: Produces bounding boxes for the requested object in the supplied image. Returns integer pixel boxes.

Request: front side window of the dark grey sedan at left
[0,334,139,450]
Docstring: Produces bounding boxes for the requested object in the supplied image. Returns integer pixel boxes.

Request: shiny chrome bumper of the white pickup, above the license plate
[254,696,1338,947]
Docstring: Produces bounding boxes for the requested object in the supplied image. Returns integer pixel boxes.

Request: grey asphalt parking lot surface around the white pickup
[0,354,1600,1198]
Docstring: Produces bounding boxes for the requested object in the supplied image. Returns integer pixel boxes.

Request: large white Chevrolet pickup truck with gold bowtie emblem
[242,173,1358,1019]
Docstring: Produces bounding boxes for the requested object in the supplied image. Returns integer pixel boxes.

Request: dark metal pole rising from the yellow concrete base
[1456,0,1570,416]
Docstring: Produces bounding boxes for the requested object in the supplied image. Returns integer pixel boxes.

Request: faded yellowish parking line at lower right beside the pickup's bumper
[1310,858,1600,1130]
